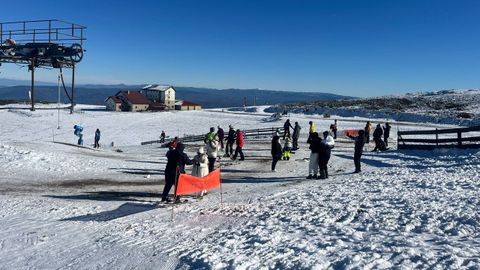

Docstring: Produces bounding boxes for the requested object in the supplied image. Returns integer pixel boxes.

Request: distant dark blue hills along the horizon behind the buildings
[0,80,351,108]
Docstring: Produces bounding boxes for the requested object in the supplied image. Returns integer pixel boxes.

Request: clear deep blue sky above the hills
[0,0,480,96]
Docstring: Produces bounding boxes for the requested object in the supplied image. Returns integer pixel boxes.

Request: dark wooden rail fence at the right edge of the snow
[397,126,480,149]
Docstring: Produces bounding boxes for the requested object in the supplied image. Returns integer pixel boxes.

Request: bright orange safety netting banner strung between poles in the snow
[176,169,220,195]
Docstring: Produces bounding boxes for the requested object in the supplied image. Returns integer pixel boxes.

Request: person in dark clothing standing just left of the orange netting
[162,142,193,202]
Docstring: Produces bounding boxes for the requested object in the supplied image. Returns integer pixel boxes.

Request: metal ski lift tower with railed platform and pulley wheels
[0,20,86,113]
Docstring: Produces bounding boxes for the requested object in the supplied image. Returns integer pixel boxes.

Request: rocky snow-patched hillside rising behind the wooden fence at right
[268,89,480,126]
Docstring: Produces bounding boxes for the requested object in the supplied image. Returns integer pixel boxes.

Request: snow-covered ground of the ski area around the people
[0,105,480,269]
